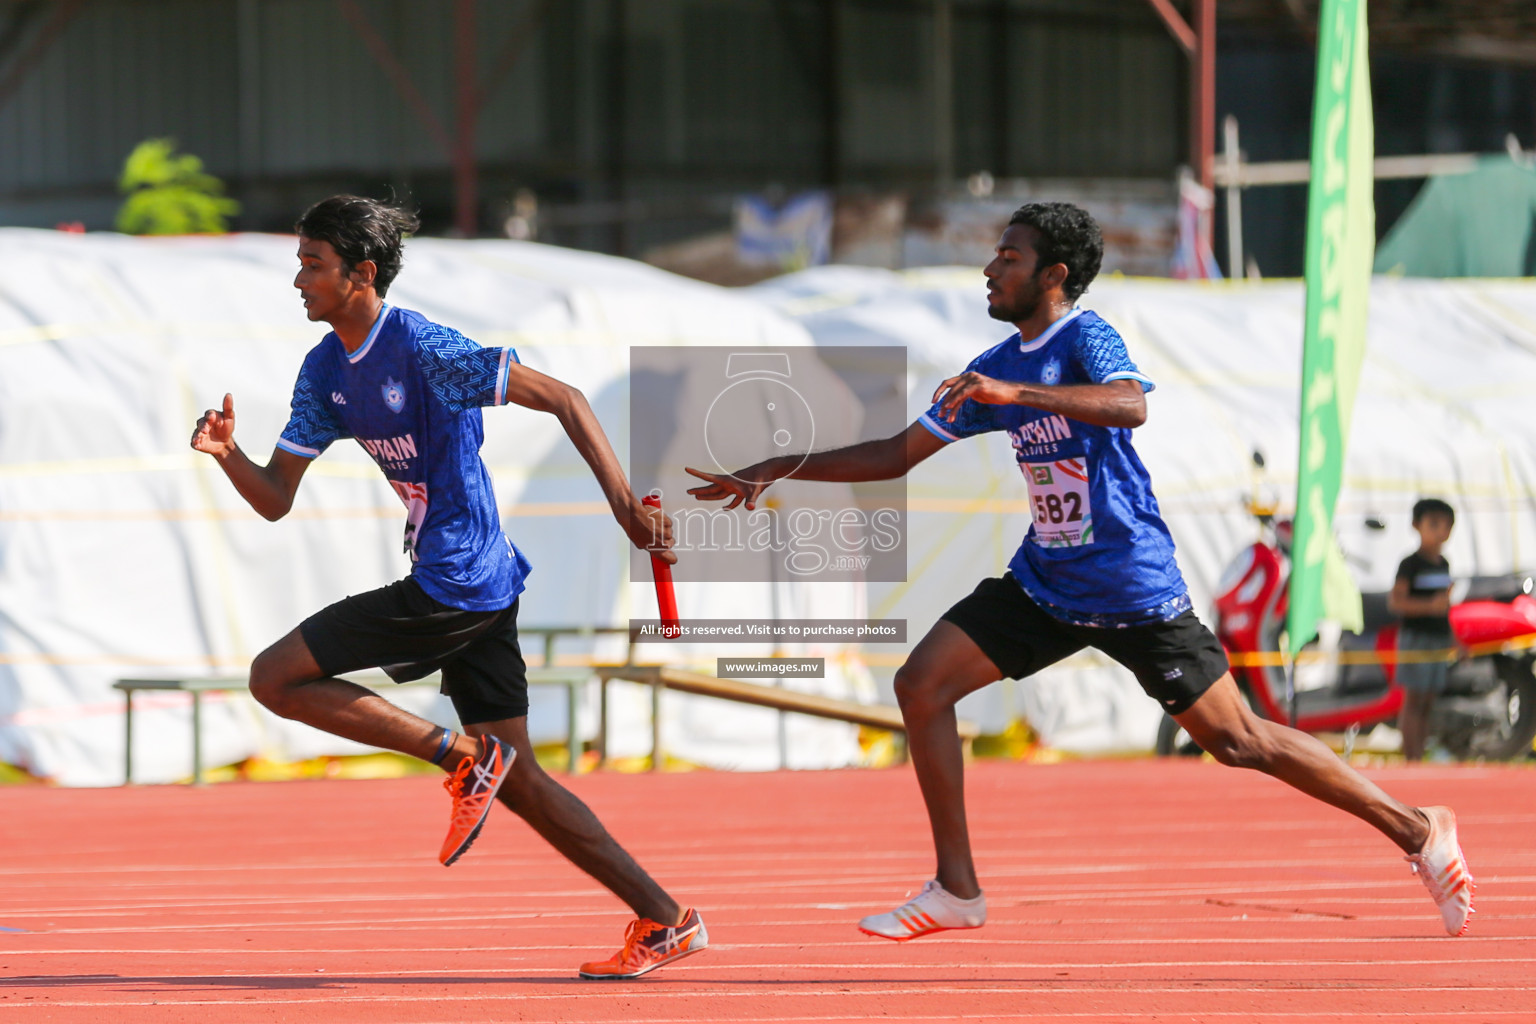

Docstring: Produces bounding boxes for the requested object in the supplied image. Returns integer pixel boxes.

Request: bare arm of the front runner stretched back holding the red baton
[505,362,677,562]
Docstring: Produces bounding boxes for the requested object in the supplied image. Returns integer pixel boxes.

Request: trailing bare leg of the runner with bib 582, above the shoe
[1174,672,1430,854]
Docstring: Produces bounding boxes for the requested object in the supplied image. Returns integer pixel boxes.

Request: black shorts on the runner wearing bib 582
[943,574,1227,715]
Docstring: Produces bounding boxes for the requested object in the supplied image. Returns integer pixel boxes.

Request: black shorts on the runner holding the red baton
[298,576,528,725]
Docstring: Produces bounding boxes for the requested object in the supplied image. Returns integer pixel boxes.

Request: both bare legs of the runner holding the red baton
[250,629,682,924]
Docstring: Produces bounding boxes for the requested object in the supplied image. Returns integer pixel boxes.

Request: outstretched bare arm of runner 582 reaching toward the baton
[685,424,945,510]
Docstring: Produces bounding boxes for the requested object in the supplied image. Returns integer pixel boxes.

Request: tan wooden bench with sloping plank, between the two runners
[593,665,982,771]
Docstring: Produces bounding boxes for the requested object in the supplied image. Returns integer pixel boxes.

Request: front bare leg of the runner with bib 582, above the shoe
[895,619,1003,900]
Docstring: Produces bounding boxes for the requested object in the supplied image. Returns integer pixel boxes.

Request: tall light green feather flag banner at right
[1286,0,1376,654]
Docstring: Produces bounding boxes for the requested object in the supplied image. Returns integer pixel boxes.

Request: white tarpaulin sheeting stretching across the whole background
[0,230,1536,785]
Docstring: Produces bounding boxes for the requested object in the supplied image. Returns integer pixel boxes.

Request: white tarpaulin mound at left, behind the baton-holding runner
[0,230,874,785]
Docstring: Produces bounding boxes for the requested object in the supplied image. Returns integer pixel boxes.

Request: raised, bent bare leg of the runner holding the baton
[250,629,458,763]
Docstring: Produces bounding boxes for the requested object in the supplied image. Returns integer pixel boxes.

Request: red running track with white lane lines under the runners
[0,761,1536,1024]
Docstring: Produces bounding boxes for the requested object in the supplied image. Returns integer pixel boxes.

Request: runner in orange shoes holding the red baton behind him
[192,195,708,978]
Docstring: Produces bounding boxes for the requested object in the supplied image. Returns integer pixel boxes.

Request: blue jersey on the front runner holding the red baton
[278,306,530,611]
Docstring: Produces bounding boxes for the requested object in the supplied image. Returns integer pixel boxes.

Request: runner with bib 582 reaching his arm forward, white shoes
[688,203,1471,941]
